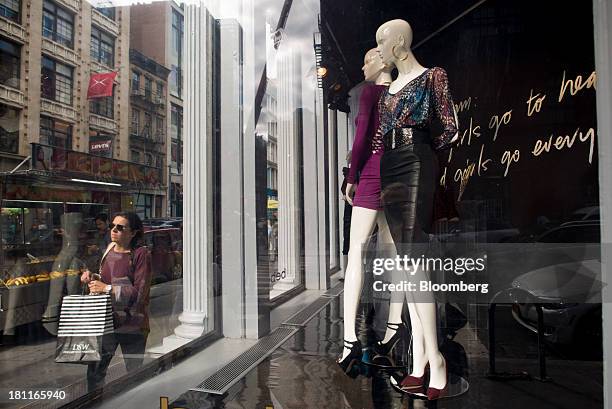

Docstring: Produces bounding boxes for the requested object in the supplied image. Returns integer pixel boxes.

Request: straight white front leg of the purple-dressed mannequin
[342,207,380,359]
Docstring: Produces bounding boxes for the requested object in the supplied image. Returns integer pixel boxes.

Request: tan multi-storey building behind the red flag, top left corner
[0,0,130,170]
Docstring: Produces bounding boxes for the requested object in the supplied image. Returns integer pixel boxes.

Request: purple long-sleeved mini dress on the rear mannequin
[346,84,387,210]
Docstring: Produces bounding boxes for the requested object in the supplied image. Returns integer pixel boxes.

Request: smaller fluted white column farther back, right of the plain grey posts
[274,47,302,290]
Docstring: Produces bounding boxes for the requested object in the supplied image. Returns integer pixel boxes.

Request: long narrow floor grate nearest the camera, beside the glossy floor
[191,326,298,395]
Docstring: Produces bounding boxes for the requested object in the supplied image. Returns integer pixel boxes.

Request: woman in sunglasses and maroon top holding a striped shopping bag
[81,212,151,391]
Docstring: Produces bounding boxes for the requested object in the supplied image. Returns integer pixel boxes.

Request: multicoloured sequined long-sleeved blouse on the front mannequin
[377,67,458,150]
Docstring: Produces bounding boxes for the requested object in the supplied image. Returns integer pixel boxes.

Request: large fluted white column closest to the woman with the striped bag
[150,5,213,353]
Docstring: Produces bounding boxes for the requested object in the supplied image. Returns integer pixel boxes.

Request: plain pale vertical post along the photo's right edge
[593,0,612,409]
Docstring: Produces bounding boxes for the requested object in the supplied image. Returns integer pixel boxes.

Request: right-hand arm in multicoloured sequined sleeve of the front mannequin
[433,68,459,150]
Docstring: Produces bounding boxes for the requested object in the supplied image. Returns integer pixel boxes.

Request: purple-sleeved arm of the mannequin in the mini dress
[346,86,378,184]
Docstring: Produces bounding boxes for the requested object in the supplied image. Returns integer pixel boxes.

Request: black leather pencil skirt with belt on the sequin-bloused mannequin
[380,128,438,249]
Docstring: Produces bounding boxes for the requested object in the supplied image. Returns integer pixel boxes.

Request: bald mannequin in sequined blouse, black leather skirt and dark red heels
[376,20,459,400]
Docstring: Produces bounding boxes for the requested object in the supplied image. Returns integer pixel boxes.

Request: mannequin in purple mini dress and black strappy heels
[337,49,402,372]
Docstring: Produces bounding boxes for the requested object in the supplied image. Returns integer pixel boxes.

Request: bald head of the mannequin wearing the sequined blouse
[376,19,412,65]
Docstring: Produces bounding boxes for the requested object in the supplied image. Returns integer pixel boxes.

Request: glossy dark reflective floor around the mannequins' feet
[169,297,603,409]
